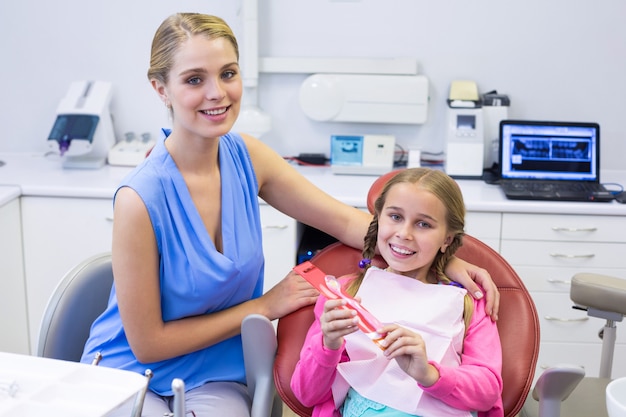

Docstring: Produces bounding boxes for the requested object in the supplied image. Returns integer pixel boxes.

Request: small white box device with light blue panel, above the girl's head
[330,135,396,175]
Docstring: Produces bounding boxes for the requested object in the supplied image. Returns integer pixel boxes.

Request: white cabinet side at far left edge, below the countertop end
[0,198,29,354]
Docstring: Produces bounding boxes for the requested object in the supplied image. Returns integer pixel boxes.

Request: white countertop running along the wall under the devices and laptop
[0,153,626,216]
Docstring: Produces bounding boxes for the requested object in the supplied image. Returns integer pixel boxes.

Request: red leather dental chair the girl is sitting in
[274,172,539,417]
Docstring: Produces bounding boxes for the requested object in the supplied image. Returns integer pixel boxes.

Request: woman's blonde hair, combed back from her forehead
[148,13,239,84]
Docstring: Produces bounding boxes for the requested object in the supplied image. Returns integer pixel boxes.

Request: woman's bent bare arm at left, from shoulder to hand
[112,187,317,362]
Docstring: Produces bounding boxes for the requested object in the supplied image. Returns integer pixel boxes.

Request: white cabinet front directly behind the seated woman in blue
[14,197,296,353]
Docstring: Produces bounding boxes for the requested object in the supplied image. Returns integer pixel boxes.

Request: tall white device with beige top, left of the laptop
[445,81,485,178]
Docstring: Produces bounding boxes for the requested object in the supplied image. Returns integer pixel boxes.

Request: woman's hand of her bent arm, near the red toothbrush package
[261,271,319,320]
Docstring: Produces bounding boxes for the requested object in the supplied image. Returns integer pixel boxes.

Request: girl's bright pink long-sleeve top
[291,290,504,417]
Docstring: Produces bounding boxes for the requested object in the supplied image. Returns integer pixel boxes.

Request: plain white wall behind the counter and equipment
[0,0,626,169]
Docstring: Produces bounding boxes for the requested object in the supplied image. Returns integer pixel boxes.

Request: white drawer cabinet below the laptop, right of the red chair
[501,213,626,377]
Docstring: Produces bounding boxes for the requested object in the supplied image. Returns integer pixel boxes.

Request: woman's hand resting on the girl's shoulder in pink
[445,256,500,321]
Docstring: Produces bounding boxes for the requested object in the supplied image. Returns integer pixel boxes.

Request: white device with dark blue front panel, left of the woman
[48,81,115,169]
